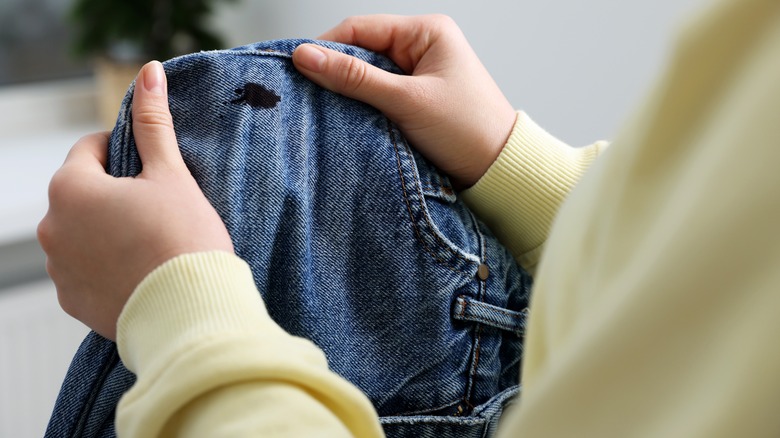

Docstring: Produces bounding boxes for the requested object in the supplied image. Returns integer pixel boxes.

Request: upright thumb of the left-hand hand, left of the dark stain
[132,61,186,170]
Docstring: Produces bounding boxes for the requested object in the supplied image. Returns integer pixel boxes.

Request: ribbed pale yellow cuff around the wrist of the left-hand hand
[117,251,287,373]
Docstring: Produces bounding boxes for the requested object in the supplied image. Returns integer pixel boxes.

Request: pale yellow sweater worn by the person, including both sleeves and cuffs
[117,0,780,437]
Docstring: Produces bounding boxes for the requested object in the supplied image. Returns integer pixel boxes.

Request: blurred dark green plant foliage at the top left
[71,0,232,61]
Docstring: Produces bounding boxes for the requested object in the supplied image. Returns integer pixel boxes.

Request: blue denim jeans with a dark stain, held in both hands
[42,40,530,437]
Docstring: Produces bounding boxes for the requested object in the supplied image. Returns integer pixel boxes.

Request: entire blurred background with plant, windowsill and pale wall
[0,0,705,437]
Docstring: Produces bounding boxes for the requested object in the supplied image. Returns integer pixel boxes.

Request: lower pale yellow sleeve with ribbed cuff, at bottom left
[117,252,382,437]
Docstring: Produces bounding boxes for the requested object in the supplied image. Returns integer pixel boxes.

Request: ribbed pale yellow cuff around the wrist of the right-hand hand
[462,111,607,270]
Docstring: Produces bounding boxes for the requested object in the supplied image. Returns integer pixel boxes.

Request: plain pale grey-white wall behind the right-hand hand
[213,0,705,145]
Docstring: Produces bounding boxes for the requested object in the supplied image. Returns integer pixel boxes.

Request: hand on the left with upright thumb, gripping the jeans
[38,62,233,339]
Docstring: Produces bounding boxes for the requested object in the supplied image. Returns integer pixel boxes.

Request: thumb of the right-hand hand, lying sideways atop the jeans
[293,44,407,113]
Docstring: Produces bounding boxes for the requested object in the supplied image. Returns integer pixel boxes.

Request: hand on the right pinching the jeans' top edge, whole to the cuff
[293,15,516,188]
